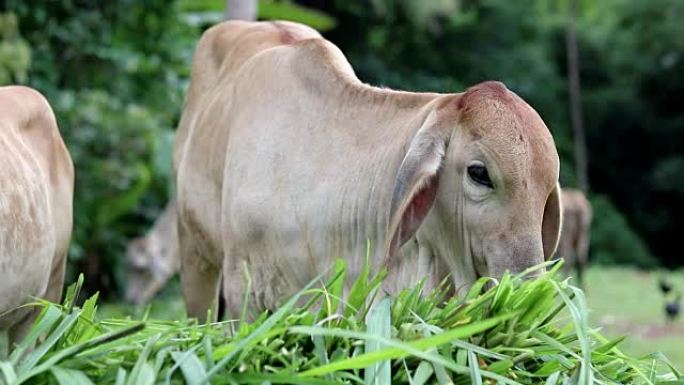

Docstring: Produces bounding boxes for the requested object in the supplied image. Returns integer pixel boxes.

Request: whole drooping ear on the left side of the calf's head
[385,119,447,258]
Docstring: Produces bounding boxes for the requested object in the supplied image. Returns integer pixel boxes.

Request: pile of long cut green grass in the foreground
[0,261,684,385]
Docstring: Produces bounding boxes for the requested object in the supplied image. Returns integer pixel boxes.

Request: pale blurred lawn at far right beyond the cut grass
[586,267,684,369]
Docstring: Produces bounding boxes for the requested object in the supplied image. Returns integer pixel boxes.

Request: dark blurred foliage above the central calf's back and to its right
[312,0,684,265]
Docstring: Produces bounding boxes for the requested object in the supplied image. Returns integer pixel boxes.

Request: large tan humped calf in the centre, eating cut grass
[174,22,560,318]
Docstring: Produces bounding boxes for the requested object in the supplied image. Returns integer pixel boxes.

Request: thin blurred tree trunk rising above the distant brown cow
[565,0,589,192]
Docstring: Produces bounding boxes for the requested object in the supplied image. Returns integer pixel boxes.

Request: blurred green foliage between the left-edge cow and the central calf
[0,0,200,295]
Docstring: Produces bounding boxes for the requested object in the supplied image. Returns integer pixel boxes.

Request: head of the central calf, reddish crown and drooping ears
[388,82,561,283]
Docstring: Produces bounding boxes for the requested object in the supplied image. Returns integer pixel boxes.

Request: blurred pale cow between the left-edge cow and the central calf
[126,202,180,305]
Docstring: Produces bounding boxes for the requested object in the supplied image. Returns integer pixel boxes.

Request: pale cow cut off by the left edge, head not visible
[0,87,74,342]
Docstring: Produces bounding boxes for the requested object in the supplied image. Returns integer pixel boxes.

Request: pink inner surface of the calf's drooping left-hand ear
[390,177,438,255]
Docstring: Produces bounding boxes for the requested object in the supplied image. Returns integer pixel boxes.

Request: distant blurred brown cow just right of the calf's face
[558,188,592,286]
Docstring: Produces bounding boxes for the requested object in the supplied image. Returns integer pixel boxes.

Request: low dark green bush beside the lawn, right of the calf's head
[590,195,658,267]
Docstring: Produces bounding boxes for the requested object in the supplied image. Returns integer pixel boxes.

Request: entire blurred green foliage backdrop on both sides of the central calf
[0,0,684,294]
